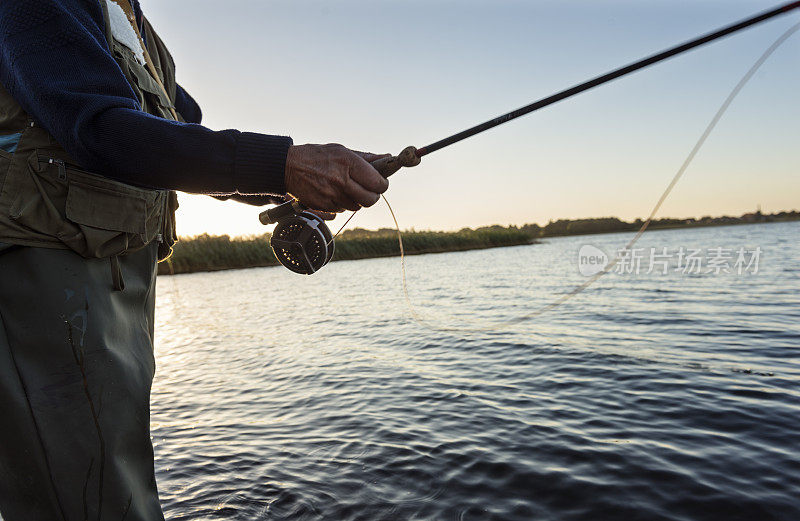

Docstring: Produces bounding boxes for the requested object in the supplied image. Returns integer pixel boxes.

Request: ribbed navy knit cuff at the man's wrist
[233,132,292,194]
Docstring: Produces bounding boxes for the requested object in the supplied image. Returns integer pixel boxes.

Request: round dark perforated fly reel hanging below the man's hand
[259,201,334,275]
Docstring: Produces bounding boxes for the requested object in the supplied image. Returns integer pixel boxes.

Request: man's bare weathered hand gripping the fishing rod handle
[286,144,390,212]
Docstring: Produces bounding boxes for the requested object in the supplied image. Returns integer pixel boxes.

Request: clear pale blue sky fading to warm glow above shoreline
[141,0,800,236]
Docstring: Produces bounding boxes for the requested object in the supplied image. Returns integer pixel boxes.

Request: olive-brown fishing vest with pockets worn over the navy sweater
[0,0,181,266]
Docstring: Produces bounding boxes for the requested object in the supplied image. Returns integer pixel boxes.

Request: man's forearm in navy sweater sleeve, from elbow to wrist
[86,108,292,194]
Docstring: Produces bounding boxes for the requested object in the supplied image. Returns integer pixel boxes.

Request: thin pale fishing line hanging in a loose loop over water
[388,23,800,333]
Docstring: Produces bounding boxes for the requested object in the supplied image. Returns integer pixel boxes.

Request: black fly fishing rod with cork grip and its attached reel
[259,1,800,275]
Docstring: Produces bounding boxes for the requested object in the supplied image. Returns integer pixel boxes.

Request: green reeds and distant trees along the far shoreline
[158,210,800,275]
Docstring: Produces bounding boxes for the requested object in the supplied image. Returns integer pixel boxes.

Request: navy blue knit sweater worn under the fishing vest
[0,0,292,202]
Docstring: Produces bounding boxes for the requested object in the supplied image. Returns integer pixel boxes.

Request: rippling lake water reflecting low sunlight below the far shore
[147,223,800,521]
